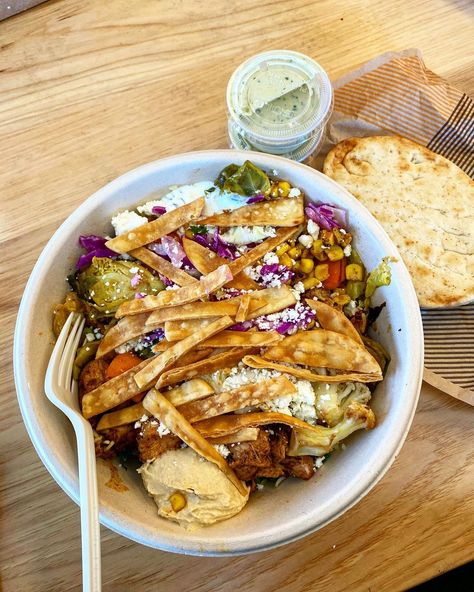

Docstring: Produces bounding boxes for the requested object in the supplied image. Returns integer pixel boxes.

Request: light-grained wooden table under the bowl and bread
[0,0,474,592]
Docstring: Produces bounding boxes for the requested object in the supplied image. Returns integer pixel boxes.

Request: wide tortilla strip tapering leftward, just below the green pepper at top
[199,195,304,227]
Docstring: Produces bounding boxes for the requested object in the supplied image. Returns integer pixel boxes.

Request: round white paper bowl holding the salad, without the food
[14,150,423,555]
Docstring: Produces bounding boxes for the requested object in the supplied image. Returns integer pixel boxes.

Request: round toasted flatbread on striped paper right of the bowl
[323,136,474,307]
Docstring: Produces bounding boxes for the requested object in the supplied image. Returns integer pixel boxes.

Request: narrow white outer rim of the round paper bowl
[13,149,423,557]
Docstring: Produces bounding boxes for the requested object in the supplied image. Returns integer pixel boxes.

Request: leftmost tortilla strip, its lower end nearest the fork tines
[82,356,156,419]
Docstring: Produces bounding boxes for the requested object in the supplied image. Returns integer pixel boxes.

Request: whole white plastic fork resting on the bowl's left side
[44,313,101,592]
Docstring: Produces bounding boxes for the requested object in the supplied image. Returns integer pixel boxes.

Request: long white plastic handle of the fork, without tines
[73,421,101,592]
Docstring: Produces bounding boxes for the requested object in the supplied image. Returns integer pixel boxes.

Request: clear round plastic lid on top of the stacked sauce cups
[227,50,333,145]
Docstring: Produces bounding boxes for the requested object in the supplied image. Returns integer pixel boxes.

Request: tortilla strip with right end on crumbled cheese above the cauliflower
[179,376,296,423]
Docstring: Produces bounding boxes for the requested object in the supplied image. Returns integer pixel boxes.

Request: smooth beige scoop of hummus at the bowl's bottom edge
[138,448,248,526]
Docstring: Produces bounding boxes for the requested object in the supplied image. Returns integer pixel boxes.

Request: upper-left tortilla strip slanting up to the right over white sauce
[105,197,205,253]
